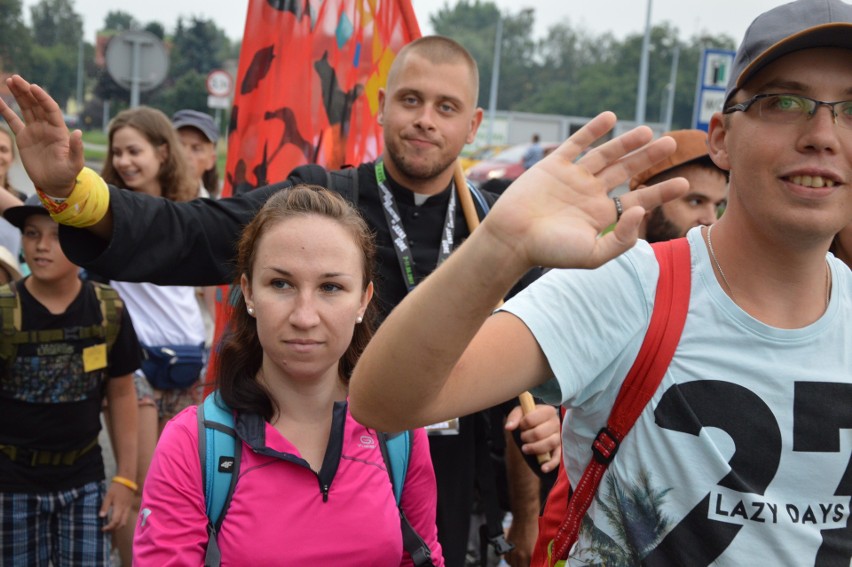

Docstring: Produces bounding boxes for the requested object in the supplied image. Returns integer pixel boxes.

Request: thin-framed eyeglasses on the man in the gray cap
[722,94,852,130]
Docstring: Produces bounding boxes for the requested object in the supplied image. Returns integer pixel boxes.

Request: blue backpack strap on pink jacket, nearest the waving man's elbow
[378,431,434,567]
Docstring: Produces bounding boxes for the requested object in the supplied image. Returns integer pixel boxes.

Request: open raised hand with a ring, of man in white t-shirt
[480,112,688,268]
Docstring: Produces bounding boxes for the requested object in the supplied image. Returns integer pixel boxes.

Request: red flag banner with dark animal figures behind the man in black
[208,0,420,390]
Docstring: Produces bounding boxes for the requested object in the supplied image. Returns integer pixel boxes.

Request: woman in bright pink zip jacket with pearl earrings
[133,186,444,567]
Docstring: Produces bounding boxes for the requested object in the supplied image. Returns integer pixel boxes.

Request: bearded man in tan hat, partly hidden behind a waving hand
[630,130,728,242]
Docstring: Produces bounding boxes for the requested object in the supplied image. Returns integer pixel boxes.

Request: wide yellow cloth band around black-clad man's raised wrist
[39,167,109,228]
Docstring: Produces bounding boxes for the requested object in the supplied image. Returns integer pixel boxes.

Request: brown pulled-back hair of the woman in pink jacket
[216,185,376,421]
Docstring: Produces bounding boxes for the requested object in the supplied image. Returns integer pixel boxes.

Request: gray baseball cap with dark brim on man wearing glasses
[725,0,852,106]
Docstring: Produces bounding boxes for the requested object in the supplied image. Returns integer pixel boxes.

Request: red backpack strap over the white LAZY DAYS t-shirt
[552,238,692,559]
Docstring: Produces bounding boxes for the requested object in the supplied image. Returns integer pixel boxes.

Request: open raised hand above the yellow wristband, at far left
[0,75,83,197]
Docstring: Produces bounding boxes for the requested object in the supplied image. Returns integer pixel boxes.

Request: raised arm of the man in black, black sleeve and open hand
[0,75,289,285]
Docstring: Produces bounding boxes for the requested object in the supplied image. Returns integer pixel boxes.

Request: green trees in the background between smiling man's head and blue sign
[430,0,735,128]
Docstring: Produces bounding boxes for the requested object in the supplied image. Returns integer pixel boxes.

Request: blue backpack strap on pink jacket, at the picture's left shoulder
[198,391,242,567]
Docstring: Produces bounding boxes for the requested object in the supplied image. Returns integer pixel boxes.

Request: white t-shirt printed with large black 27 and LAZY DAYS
[504,229,852,567]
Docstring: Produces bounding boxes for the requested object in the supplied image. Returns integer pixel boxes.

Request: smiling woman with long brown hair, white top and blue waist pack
[98,106,211,564]
